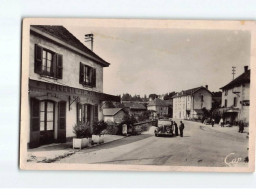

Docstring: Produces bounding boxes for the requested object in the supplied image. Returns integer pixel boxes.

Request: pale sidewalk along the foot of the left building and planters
[27,135,125,163]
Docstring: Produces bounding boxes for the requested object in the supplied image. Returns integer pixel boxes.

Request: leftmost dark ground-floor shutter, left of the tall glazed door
[29,98,40,148]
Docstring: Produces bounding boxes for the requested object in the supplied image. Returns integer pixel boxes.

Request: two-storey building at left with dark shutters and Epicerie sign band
[27,25,120,148]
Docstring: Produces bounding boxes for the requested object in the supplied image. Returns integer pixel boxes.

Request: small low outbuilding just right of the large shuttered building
[103,108,126,123]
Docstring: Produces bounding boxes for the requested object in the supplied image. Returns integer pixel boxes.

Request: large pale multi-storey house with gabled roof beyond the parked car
[173,85,212,119]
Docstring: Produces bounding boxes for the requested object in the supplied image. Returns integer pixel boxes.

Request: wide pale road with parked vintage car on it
[55,121,248,167]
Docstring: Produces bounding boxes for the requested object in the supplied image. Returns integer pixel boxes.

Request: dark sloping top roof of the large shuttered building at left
[31,25,109,66]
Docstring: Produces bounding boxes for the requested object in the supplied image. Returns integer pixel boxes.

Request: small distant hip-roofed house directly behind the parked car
[147,98,168,117]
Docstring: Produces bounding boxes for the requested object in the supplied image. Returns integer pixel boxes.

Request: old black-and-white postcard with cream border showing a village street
[20,18,256,172]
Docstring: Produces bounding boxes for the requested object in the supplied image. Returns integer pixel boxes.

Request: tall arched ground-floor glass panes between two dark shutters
[40,101,54,131]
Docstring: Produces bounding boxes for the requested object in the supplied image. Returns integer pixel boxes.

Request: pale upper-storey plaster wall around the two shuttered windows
[29,34,103,92]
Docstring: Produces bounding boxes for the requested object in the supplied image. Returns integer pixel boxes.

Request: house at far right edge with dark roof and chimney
[219,66,250,124]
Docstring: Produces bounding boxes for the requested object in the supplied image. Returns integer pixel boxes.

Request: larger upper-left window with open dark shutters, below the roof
[35,44,63,79]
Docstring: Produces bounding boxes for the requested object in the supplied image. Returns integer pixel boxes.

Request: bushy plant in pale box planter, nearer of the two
[73,123,90,149]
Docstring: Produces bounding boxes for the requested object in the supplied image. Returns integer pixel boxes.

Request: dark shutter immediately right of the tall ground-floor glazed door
[57,102,66,143]
